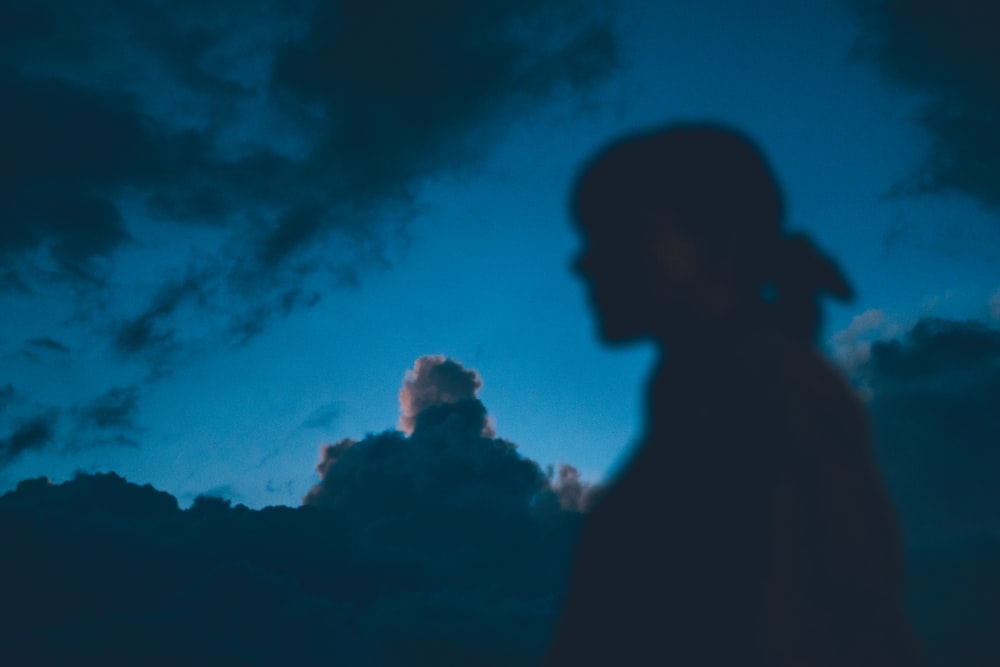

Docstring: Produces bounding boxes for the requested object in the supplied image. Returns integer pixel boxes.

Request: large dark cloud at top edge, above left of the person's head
[273,0,616,201]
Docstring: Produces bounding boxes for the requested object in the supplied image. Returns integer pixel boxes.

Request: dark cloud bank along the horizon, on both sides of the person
[0,336,1000,667]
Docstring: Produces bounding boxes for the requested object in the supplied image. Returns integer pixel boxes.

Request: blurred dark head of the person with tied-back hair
[572,124,850,342]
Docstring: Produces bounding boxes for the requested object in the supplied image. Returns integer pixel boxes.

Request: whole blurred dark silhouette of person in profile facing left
[546,124,920,667]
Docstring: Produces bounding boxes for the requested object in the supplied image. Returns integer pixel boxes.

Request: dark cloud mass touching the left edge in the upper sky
[0,69,147,284]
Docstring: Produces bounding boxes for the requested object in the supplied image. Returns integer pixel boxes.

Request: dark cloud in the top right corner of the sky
[847,0,1000,210]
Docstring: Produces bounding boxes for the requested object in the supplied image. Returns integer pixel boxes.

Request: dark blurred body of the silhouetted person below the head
[546,122,919,667]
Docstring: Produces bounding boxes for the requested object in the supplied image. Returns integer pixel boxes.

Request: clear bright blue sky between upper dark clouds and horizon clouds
[0,0,1000,507]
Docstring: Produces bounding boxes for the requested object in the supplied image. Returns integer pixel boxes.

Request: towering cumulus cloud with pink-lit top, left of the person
[303,355,592,528]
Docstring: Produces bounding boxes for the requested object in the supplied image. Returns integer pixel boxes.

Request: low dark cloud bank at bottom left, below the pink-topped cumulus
[0,473,563,667]
